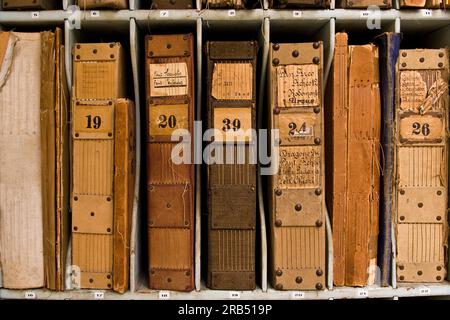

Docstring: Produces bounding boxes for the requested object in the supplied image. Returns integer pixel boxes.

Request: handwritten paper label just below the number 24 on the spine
[278,146,321,189]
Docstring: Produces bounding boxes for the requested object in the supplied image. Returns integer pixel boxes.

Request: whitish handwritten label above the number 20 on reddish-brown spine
[149,62,189,97]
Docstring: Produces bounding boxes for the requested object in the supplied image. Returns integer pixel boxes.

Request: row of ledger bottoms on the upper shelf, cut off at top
[2,0,450,10]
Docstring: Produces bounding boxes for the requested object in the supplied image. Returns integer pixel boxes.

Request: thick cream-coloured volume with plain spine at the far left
[0,32,46,289]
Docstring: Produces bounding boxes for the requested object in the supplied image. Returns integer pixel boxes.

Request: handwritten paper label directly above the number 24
[276,64,320,107]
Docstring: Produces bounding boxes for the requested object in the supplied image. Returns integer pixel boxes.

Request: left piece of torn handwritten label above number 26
[400,71,427,113]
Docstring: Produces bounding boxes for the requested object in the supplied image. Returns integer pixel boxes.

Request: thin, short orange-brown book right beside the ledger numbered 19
[113,99,136,293]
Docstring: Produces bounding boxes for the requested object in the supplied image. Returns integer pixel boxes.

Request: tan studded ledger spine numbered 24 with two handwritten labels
[269,42,326,290]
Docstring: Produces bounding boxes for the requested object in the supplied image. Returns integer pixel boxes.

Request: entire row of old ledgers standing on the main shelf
[0,29,449,292]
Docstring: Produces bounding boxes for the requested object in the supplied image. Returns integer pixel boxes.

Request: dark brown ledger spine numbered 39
[206,41,257,290]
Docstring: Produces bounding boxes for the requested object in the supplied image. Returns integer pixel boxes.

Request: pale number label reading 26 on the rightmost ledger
[400,115,444,142]
